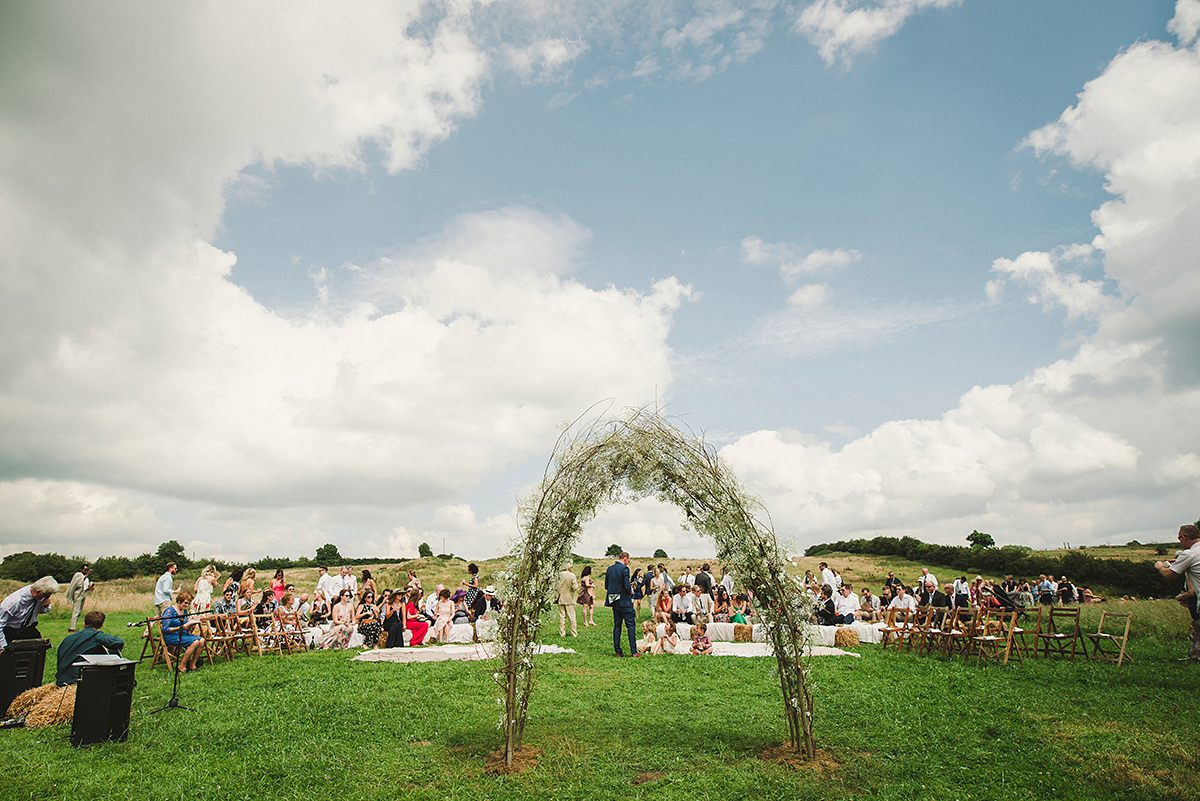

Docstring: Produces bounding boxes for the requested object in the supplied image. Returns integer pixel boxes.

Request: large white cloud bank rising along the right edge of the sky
[721,20,1200,546]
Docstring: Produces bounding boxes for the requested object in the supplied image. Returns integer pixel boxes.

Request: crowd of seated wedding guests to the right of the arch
[804,562,1103,626]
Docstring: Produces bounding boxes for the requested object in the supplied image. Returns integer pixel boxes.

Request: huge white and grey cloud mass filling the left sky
[0,4,688,555]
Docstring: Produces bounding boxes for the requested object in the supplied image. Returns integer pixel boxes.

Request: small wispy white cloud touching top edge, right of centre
[793,0,959,65]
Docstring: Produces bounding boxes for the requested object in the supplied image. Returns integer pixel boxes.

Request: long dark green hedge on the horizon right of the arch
[804,531,1178,597]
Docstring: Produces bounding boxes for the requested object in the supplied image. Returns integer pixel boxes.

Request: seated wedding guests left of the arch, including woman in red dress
[155,564,500,652]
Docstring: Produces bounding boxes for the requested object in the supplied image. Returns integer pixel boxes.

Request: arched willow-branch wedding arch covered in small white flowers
[497,409,815,766]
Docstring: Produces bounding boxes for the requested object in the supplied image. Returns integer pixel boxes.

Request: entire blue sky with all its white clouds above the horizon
[0,0,1200,558]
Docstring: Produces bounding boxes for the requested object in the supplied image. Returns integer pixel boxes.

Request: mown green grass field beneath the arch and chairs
[0,559,1200,801]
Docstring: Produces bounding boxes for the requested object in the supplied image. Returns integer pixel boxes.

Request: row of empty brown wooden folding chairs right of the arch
[882,607,1133,666]
